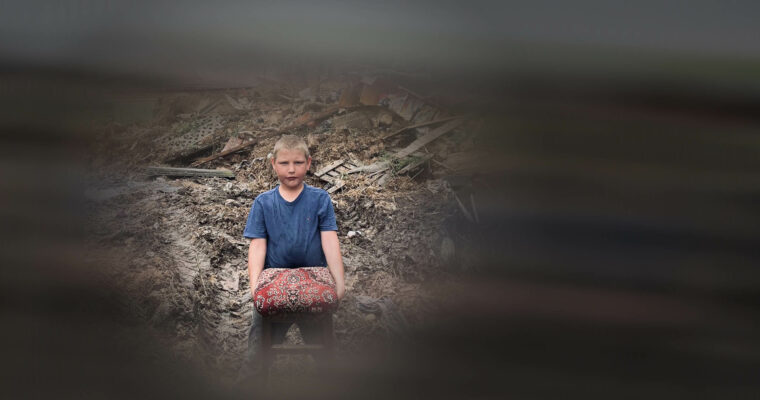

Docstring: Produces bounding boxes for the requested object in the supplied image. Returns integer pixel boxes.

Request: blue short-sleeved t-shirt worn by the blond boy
[243,184,338,268]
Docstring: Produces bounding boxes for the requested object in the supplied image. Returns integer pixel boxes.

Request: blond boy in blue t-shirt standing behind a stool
[241,135,346,379]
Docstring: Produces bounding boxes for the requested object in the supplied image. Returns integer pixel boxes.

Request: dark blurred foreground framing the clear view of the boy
[0,2,760,399]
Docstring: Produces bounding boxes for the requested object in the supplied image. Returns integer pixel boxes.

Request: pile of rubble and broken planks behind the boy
[88,70,478,376]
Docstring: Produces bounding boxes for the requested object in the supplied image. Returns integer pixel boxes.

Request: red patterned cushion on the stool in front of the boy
[253,267,338,316]
